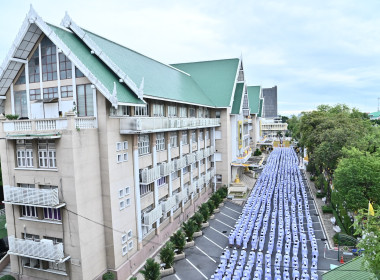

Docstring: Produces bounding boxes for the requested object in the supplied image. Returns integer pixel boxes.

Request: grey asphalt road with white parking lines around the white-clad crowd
[163,170,339,280]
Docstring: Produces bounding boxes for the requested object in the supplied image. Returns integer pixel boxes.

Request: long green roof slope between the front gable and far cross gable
[80,30,215,107]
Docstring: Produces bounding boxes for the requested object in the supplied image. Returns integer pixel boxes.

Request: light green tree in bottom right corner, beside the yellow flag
[353,208,380,276]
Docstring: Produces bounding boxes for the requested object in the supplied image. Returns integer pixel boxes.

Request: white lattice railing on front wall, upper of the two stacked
[4,186,59,206]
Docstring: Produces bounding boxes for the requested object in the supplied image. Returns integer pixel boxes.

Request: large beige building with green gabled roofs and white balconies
[0,8,262,279]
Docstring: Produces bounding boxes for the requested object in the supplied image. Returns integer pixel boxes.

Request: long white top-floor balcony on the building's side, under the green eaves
[120,117,220,134]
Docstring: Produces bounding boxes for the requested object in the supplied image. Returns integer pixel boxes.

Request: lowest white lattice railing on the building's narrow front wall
[8,236,64,262]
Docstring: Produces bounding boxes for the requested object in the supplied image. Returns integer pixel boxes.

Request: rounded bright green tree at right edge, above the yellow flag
[333,148,380,211]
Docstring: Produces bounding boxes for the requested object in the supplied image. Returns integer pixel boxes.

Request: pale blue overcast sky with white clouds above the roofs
[0,0,380,115]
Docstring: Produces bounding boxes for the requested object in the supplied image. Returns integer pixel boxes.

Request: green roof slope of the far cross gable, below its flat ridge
[172,58,239,107]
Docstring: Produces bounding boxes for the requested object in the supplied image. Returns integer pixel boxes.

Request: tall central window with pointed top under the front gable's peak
[41,36,57,82]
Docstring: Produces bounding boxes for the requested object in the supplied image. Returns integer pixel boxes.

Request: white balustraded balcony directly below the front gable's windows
[2,116,97,138]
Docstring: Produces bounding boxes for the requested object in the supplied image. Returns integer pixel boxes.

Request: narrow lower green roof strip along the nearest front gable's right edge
[48,24,144,104]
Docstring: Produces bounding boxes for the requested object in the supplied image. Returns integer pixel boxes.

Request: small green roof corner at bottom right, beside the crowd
[322,257,378,280]
